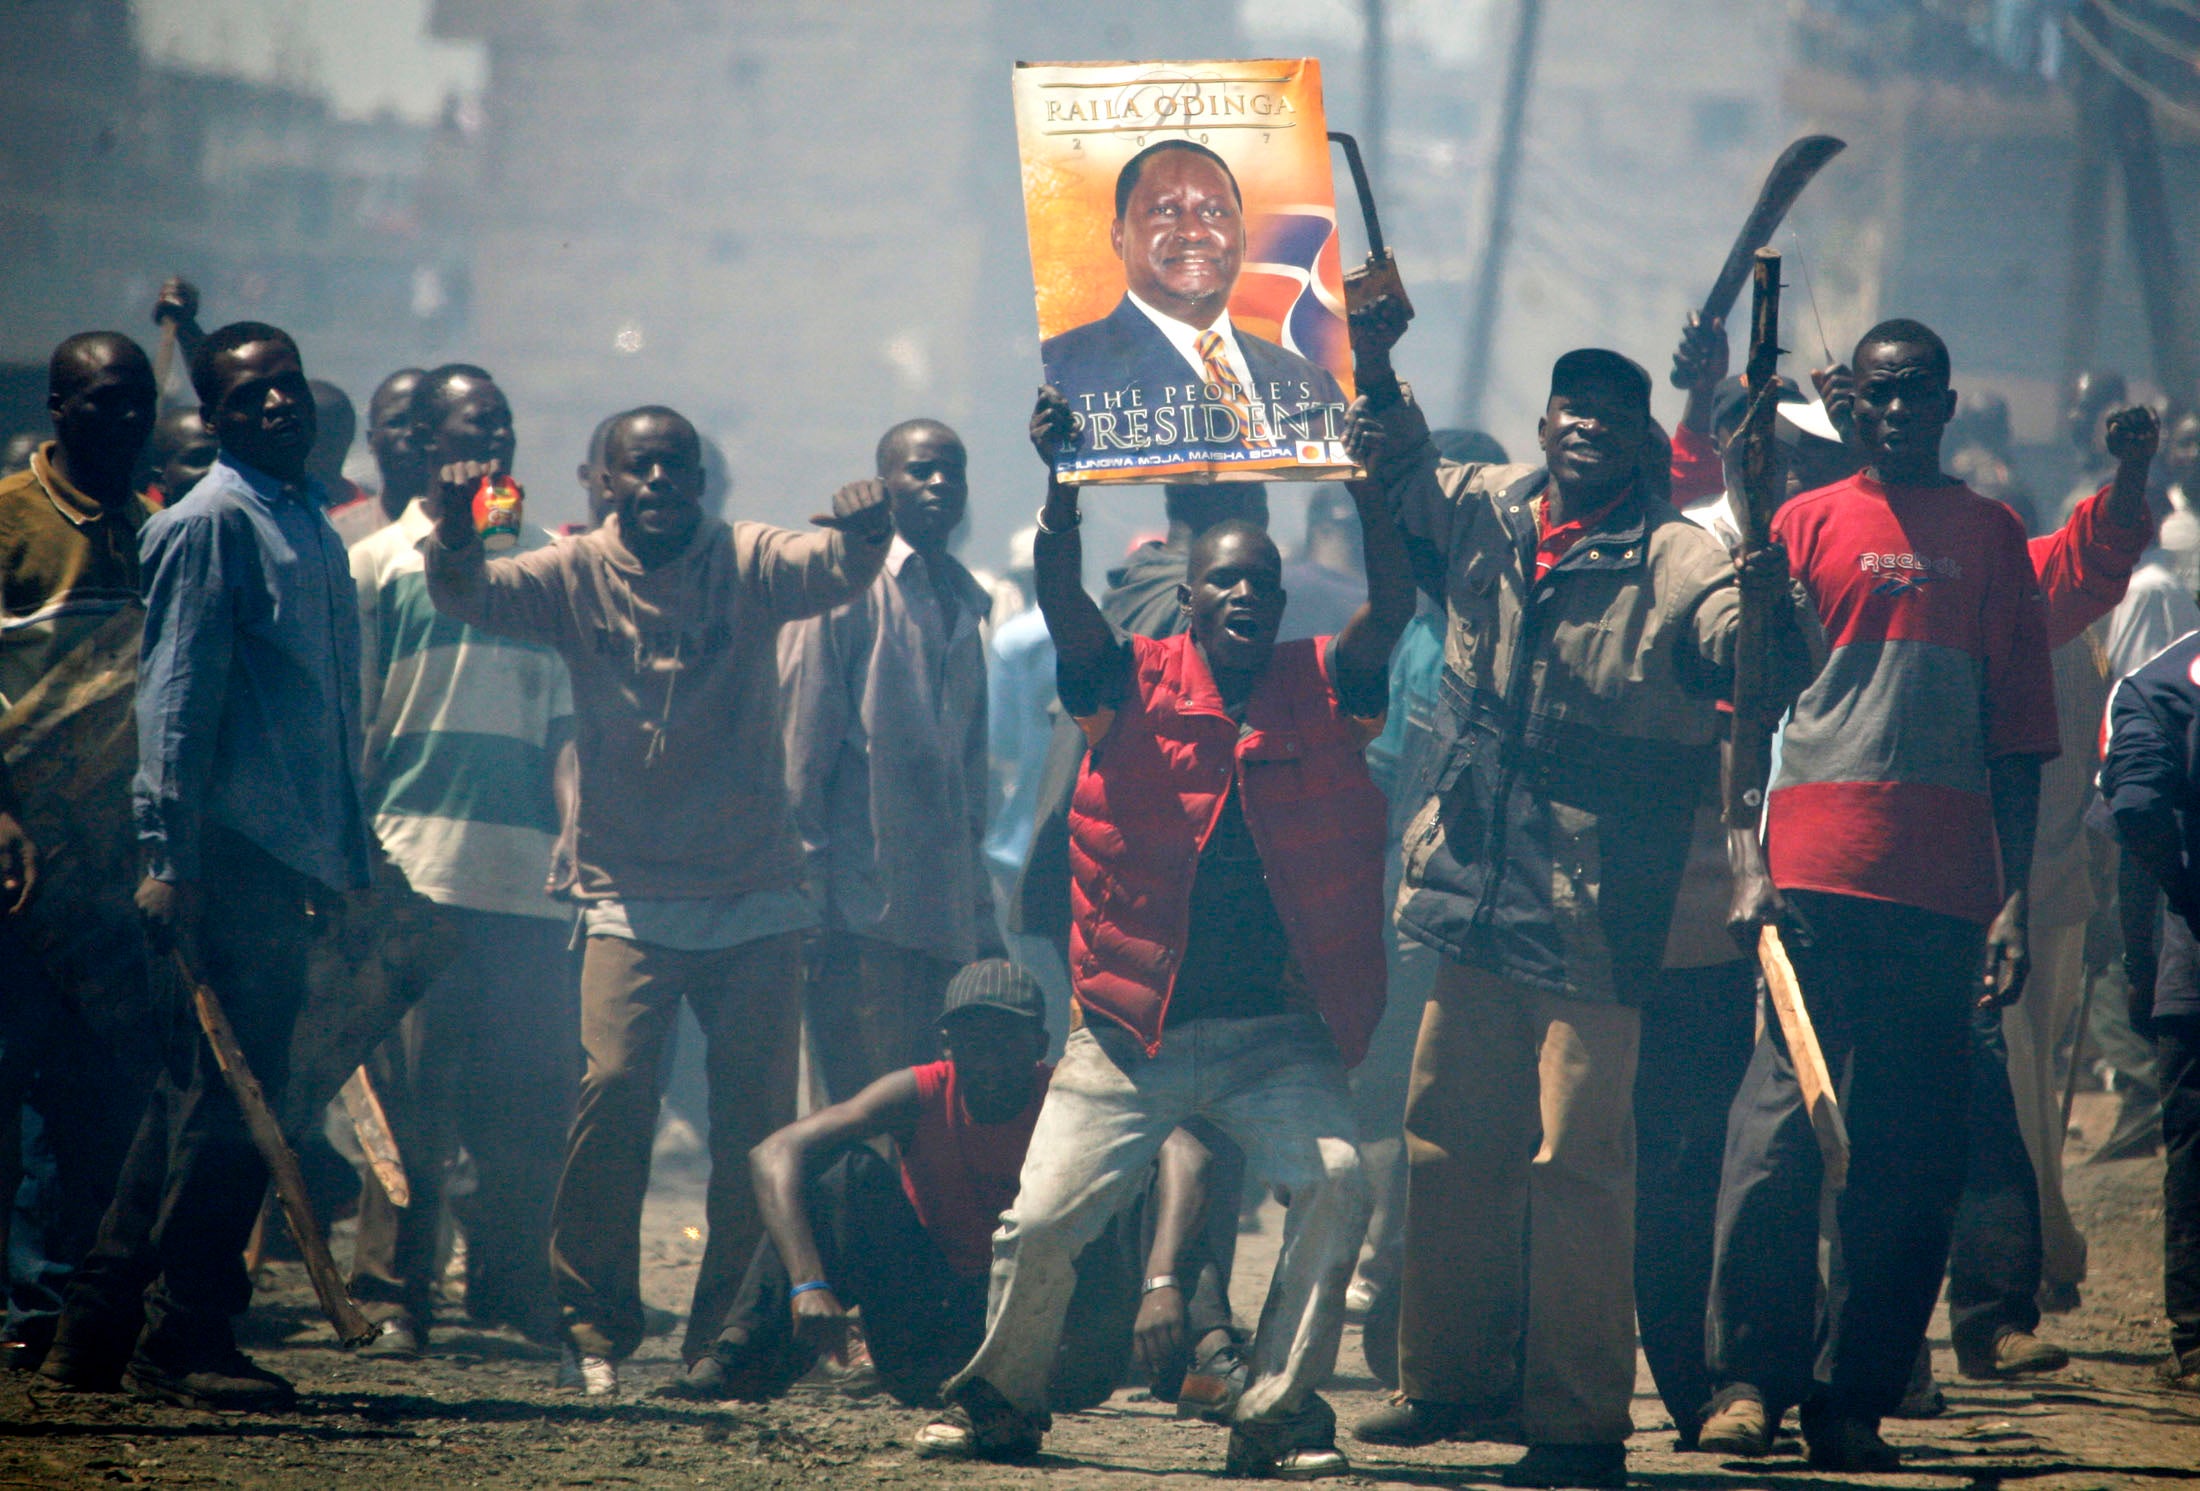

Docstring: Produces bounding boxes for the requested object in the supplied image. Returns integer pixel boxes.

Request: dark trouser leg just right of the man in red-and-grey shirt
[1947,1009,2044,1359]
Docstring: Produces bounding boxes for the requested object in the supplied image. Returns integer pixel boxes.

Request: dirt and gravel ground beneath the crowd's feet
[0,1100,2200,1491]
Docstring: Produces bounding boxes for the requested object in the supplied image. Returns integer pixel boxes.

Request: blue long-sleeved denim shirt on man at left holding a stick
[132,455,367,891]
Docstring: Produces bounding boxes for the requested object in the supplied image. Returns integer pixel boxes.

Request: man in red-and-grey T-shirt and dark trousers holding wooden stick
[1701,321,2057,1471]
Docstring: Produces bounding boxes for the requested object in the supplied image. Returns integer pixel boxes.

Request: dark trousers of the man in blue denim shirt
[59,827,326,1368]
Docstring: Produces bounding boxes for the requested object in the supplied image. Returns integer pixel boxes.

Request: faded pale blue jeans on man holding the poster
[942,1014,1368,1421]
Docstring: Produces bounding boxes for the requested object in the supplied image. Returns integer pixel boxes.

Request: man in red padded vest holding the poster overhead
[917,389,1412,1478]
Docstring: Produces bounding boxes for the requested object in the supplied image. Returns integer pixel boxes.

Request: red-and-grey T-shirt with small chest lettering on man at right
[1767,475,2059,924]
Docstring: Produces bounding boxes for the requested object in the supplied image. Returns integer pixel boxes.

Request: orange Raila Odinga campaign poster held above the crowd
[1012,57,1355,484]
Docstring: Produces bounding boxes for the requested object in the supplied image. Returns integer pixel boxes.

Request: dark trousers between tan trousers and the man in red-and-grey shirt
[1635,961,1756,1438]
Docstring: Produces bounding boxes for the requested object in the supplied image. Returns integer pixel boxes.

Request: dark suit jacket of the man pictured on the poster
[1038,295,1344,455]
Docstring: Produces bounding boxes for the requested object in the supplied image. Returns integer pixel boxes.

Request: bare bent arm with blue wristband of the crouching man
[748,1067,917,1350]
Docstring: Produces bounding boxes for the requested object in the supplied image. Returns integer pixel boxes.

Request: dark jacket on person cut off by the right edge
[2101,631,2200,1018]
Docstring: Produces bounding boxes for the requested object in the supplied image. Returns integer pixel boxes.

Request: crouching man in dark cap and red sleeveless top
[662,959,1199,1410]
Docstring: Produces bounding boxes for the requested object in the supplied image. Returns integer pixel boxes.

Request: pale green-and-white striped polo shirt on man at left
[352,501,572,917]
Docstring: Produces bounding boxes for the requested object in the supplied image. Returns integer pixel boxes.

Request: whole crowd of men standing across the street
[0,192,2200,1487]
